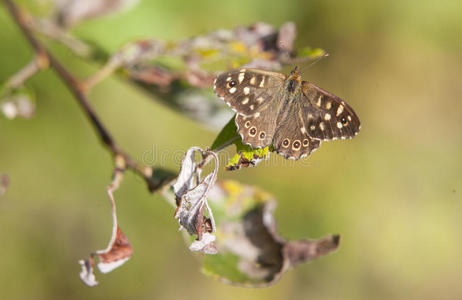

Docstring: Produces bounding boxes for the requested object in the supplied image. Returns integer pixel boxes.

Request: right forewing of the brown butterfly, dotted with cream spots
[301,81,361,140]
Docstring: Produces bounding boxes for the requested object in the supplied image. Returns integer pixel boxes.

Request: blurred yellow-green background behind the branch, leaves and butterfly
[0,0,462,300]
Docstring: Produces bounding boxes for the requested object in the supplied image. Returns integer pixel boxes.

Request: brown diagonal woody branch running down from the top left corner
[3,0,153,190]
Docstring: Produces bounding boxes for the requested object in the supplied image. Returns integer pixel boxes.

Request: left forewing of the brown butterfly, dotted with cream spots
[214,68,285,116]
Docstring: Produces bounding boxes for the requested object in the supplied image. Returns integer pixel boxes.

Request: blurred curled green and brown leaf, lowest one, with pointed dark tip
[203,181,339,287]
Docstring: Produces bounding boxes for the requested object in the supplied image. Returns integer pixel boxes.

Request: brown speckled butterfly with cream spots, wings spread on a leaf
[213,67,361,159]
